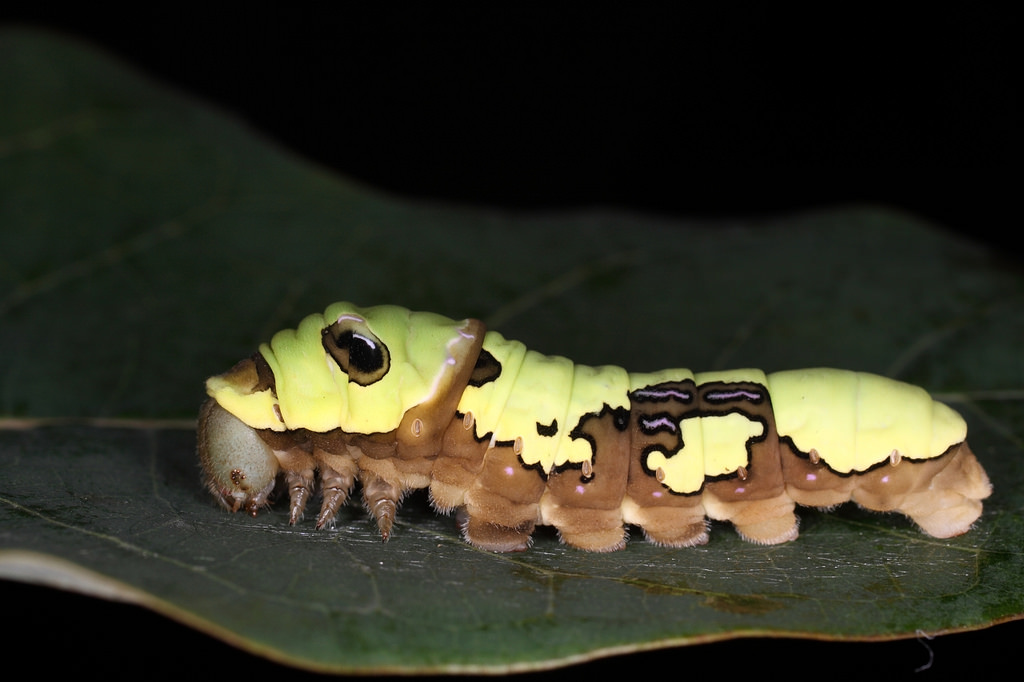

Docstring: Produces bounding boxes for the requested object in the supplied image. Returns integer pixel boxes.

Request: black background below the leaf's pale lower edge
[0,581,1024,680]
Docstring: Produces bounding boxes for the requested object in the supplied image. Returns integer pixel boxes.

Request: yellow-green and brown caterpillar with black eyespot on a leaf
[197,302,991,552]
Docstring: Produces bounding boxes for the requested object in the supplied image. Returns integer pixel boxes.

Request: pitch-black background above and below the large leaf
[0,4,1024,679]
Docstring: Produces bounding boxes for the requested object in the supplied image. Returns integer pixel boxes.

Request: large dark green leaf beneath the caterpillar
[0,31,1024,673]
